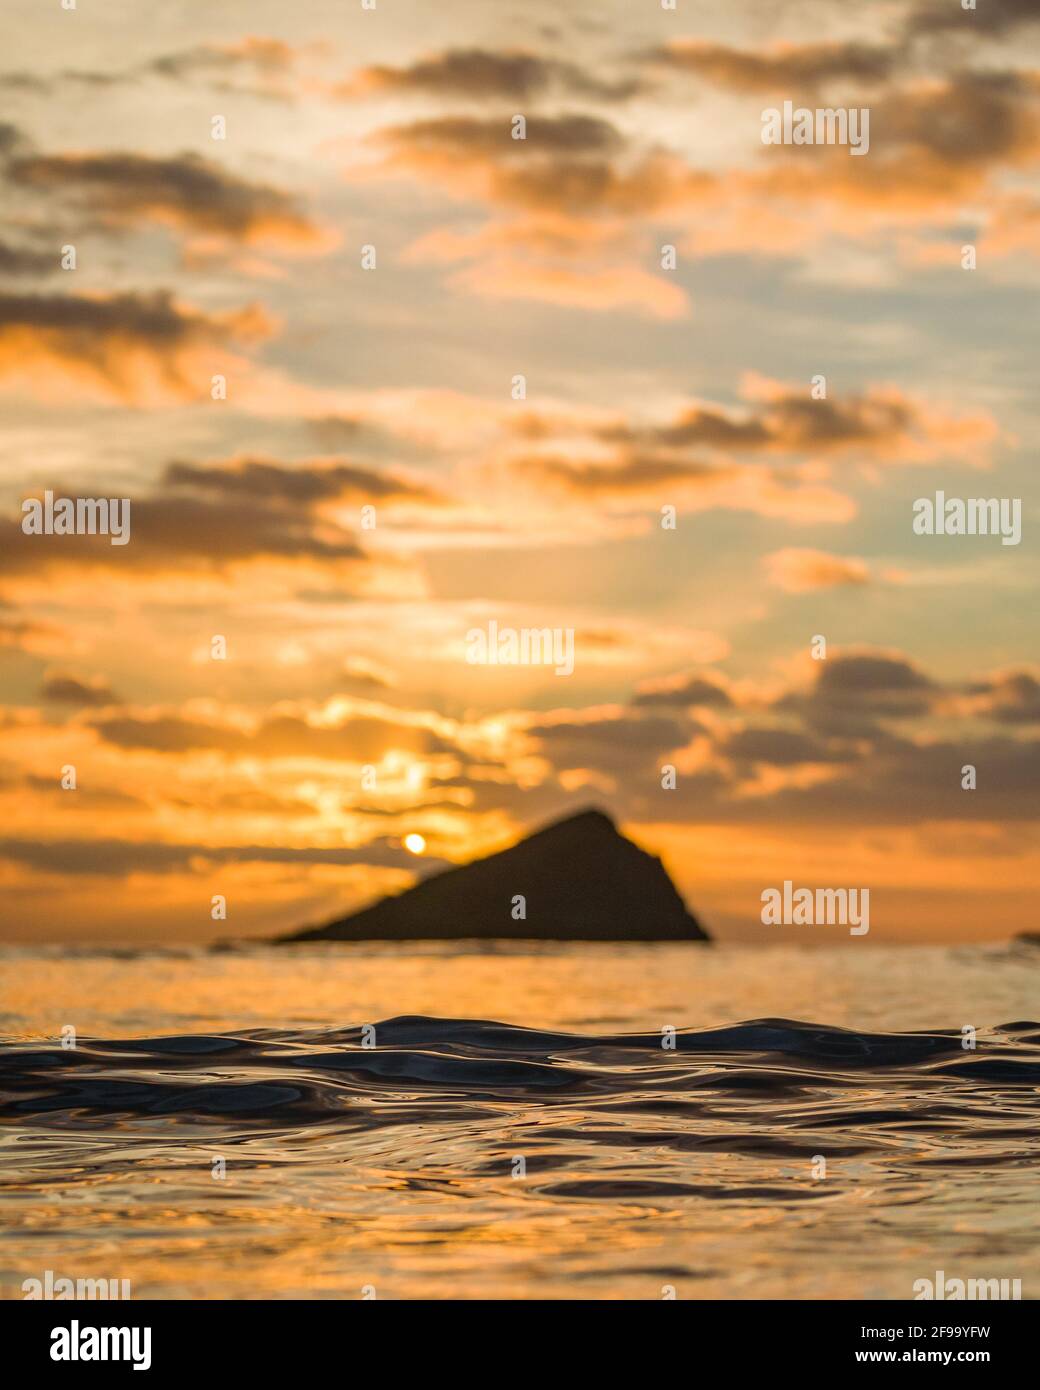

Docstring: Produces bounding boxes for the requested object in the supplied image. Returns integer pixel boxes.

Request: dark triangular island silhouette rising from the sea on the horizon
[278,809,709,945]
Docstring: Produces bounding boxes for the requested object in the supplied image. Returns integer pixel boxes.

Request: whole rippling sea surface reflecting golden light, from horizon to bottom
[0,941,1040,1300]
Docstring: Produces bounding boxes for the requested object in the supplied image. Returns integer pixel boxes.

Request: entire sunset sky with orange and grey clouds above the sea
[0,0,1040,949]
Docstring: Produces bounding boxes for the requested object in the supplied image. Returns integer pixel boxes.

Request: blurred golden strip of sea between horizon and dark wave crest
[0,942,1040,1037]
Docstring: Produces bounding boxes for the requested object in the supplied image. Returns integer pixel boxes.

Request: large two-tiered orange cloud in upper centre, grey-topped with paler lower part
[349,114,715,318]
